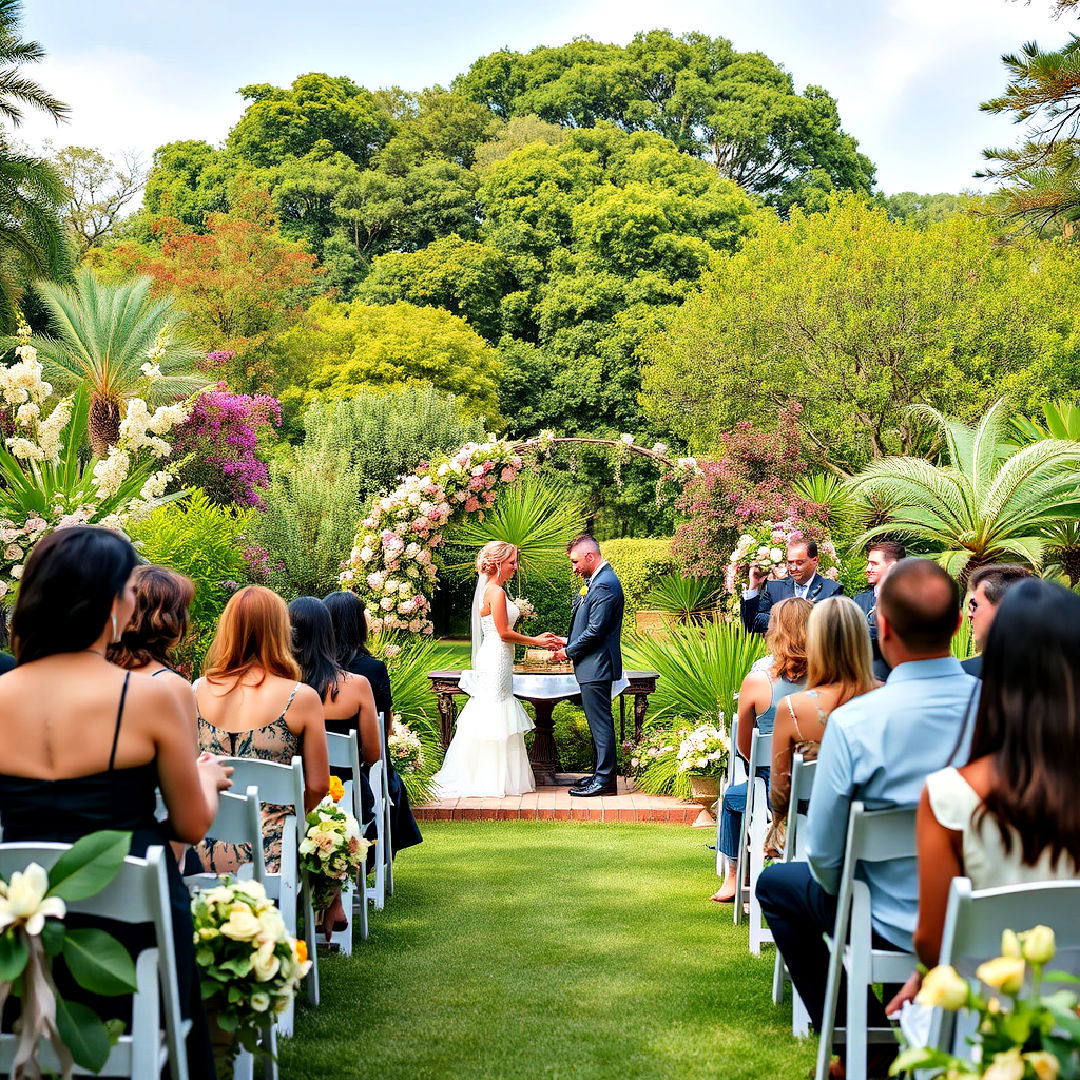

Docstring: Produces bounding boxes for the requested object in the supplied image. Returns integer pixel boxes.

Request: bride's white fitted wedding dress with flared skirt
[432,598,536,799]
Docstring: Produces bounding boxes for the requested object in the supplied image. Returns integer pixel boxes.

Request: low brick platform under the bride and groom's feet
[414,774,700,825]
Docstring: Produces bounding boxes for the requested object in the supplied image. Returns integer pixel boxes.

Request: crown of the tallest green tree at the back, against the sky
[455,30,874,211]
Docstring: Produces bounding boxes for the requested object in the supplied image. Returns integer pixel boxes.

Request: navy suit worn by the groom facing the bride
[566,563,624,784]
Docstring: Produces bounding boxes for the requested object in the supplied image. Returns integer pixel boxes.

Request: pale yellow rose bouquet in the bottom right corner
[889,926,1080,1080]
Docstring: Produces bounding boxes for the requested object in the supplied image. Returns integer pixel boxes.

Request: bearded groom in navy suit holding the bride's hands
[554,532,623,798]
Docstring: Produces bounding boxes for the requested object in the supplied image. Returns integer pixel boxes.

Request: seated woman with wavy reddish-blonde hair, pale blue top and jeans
[712,596,813,904]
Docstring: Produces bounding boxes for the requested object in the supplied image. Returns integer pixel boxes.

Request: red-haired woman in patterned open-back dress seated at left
[194,585,330,874]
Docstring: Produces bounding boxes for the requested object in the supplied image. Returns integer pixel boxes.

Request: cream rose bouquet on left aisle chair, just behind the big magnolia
[191,877,311,1053]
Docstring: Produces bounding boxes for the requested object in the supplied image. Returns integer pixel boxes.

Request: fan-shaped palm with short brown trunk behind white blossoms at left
[14,270,207,458]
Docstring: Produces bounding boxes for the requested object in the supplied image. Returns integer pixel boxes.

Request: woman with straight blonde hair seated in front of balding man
[767,596,881,850]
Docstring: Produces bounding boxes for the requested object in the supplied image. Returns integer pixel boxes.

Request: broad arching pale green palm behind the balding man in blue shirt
[851,402,1080,585]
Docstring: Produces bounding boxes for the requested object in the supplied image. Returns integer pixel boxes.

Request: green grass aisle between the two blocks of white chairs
[281,821,813,1080]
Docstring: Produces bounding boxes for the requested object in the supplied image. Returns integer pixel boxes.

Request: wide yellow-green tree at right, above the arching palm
[642,197,1080,471]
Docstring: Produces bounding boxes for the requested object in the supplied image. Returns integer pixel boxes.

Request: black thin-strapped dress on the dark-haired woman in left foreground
[0,683,215,1080]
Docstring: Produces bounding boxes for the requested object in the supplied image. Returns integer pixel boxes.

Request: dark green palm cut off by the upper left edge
[0,0,71,330]
